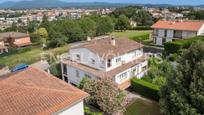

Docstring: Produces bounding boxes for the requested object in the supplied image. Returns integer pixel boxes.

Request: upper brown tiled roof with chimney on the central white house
[75,36,143,59]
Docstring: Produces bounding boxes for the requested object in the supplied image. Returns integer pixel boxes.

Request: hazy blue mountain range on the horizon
[0,0,131,9]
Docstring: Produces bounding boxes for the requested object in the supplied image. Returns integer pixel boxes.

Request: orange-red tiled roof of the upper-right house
[152,20,204,31]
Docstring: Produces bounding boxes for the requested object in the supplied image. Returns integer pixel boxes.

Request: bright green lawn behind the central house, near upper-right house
[111,30,152,44]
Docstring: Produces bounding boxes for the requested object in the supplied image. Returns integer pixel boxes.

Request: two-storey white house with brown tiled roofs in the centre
[61,36,147,89]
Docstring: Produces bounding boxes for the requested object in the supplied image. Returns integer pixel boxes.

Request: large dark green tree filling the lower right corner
[160,42,204,115]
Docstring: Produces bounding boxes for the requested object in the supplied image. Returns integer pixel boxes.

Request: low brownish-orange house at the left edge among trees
[0,32,31,53]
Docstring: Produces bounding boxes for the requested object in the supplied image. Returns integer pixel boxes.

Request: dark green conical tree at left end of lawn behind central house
[115,15,130,31]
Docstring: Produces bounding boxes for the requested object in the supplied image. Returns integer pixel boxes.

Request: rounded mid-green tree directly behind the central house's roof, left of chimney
[96,16,114,36]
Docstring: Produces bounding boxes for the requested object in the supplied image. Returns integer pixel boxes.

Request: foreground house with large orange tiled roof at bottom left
[0,67,88,115]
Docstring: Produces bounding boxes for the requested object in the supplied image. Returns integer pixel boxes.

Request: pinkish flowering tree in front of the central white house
[82,79,125,114]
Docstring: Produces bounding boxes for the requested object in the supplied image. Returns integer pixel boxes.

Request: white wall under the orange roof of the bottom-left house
[54,101,84,115]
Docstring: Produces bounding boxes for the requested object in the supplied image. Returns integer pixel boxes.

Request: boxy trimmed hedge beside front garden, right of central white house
[131,78,159,101]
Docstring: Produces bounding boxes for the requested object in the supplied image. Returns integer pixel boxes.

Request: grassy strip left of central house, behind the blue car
[0,45,68,68]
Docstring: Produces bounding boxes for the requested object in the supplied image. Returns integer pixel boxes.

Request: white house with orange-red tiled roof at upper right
[152,20,204,45]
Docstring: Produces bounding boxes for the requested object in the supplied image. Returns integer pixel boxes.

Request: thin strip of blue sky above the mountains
[0,0,204,5]
